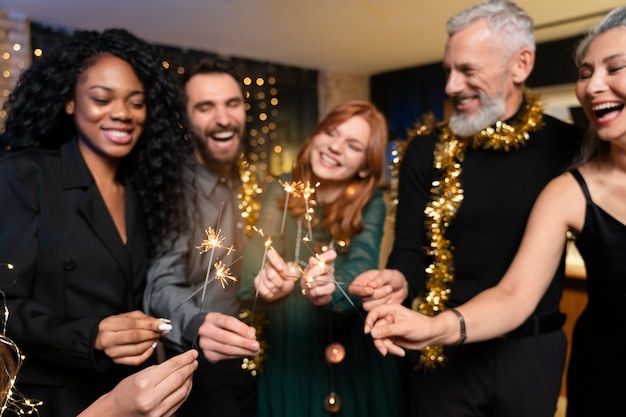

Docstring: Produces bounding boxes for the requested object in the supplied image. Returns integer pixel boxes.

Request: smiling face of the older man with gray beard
[444,19,519,136]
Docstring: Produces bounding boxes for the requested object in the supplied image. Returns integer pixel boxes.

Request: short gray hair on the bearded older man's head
[446,0,535,57]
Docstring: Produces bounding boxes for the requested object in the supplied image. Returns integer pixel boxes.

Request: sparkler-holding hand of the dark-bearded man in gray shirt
[198,312,261,363]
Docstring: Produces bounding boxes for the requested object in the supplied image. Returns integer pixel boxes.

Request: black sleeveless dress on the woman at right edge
[567,170,626,417]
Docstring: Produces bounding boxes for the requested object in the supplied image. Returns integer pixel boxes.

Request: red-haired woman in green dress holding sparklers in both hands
[239,101,404,417]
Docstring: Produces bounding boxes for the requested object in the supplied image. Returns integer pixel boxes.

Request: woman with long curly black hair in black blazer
[0,29,190,416]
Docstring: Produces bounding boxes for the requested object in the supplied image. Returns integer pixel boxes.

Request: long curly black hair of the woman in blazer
[0,29,191,254]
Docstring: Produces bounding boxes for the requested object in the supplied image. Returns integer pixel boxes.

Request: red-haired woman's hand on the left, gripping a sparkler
[254,248,300,301]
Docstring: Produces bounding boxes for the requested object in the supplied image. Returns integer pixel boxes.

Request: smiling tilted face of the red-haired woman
[311,116,371,187]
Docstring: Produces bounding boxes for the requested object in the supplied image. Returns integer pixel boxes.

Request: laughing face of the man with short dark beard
[185,73,246,171]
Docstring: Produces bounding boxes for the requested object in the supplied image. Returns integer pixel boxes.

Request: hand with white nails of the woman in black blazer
[95,310,172,366]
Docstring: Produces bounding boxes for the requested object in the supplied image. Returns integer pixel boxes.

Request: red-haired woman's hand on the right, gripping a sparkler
[300,250,337,306]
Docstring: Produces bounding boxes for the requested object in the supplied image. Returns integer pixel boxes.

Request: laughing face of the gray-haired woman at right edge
[576,27,626,141]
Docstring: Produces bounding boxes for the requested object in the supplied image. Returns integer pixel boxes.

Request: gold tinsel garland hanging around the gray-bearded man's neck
[402,90,543,368]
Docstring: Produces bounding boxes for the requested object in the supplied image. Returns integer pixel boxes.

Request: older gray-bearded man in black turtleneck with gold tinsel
[350,0,581,417]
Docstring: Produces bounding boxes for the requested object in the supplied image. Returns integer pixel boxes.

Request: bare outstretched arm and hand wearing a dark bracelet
[365,174,585,355]
